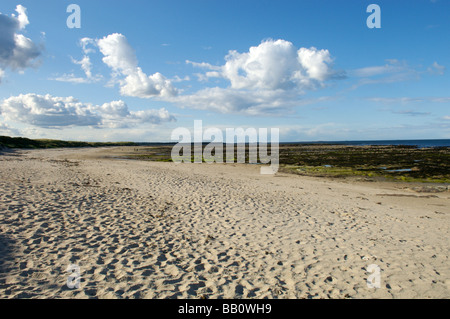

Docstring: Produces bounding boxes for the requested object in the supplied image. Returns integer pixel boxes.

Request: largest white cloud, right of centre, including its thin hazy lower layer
[176,40,343,115]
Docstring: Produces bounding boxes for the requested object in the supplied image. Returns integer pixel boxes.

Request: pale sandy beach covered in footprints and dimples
[0,148,450,299]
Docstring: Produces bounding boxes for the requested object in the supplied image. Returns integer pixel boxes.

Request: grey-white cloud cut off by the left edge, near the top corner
[0,5,41,75]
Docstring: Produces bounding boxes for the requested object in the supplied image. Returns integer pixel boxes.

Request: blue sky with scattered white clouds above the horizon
[0,0,450,142]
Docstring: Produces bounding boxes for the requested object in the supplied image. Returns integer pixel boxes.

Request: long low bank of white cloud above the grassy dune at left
[0,93,176,128]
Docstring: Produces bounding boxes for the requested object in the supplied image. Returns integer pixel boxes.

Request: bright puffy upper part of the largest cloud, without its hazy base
[192,40,337,90]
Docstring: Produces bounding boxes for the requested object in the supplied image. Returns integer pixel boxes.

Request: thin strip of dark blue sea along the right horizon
[290,139,450,148]
